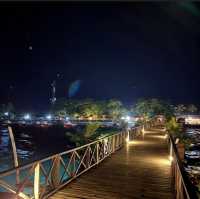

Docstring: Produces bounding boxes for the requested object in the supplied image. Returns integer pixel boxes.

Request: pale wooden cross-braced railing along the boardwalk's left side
[0,126,142,199]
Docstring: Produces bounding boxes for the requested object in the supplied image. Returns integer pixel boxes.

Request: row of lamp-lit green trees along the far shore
[0,98,198,120]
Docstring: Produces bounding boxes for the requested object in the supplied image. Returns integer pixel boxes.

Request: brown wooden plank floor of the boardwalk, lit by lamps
[50,129,174,199]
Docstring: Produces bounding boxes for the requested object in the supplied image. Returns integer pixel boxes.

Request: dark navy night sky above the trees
[0,2,200,110]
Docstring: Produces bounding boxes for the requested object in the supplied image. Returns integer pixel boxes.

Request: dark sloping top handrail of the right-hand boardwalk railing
[169,133,198,199]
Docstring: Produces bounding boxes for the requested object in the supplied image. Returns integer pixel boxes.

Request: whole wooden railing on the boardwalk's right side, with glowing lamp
[169,134,198,199]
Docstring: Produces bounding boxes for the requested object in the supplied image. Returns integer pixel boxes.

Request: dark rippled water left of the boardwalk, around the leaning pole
[0,126,74,172]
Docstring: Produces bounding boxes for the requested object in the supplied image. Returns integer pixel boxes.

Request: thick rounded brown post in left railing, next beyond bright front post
[51,156,60,187]
